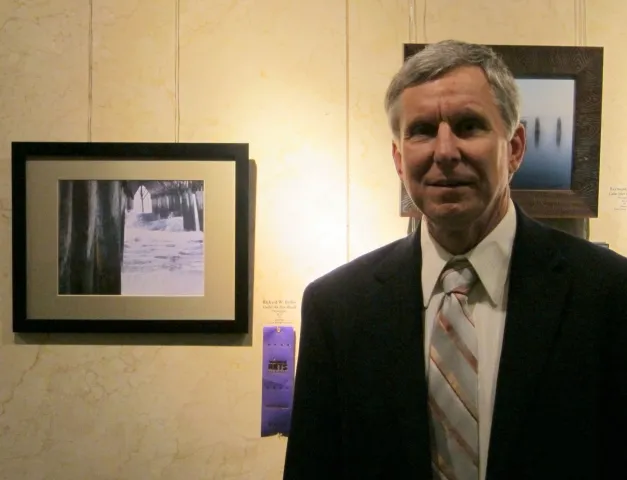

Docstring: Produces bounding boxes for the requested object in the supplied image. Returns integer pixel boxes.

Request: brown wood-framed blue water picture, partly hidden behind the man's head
[399,44,603,218]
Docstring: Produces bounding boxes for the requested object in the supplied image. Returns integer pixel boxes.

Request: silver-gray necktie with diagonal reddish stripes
[428,259,479,480]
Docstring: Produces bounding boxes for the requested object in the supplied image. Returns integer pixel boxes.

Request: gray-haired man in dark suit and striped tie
[284,41,627,480]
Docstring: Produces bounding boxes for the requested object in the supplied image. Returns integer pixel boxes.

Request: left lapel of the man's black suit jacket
[373,229,431,478]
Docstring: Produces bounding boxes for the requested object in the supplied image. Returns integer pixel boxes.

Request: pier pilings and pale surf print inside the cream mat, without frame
[59,180,205,296]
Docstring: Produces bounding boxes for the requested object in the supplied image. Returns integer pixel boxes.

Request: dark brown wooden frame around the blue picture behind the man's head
[399,44,603,218]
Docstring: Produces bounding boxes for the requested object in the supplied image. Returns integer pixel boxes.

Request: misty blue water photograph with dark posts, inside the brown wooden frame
[511,78,575,190]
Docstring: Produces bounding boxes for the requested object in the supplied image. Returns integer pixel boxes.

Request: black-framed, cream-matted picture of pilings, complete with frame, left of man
[12,142,250,333]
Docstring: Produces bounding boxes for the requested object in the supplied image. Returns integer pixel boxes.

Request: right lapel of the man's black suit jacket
[487,208,570,479]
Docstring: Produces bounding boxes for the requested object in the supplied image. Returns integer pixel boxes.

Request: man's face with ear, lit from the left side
[393,67,525,230]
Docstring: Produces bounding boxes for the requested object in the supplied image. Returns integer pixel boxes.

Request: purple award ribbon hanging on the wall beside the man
[261,325,296,437]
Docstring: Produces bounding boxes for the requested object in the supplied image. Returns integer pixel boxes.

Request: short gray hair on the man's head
[385,40,520,138]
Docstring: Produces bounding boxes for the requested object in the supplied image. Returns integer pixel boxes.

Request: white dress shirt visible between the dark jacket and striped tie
[420,200,516,479]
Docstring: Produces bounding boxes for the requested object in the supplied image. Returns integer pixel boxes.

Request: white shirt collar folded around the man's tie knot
[420,200,516,307]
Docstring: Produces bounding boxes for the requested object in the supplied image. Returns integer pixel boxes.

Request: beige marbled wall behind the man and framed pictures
[0,0,627,480]
